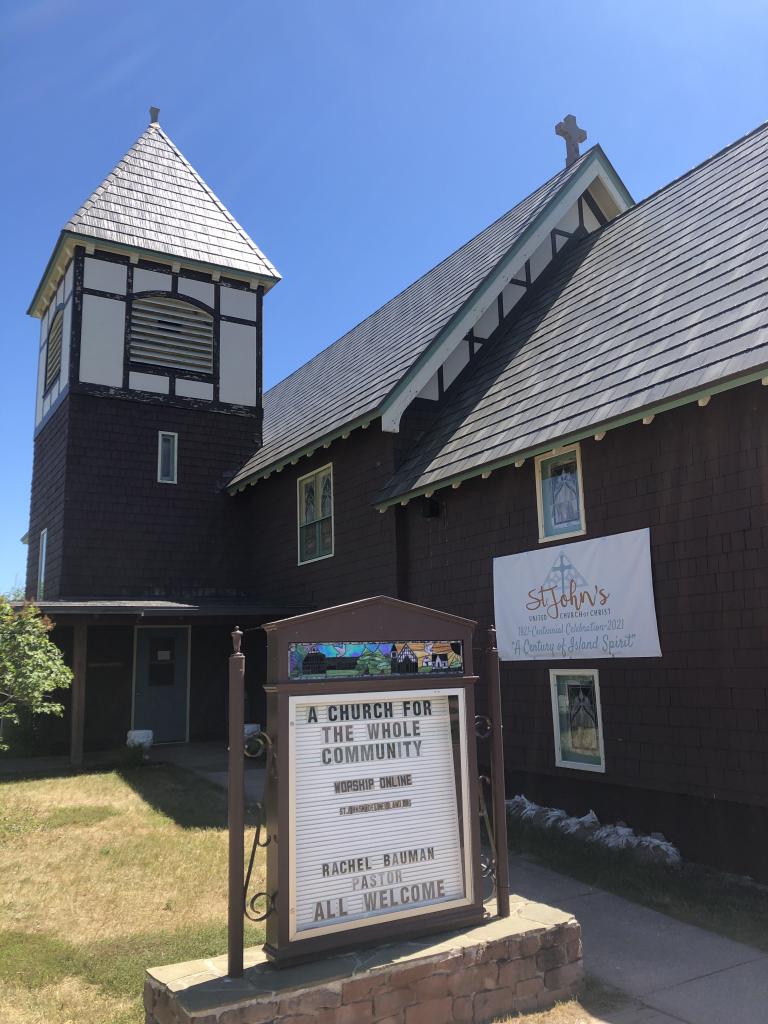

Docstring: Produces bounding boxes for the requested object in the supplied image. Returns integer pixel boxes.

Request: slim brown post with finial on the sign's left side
[226,626,246,978]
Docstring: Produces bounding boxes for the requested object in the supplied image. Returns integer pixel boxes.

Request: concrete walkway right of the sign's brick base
[510,857,768,1024]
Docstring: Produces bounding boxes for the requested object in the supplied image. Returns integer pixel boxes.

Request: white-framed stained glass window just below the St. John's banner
[550,669,605,771]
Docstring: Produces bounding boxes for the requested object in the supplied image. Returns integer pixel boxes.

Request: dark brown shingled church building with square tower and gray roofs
[27,109,768,877]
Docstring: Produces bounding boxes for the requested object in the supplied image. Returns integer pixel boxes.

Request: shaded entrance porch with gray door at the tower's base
[19,600,299,766]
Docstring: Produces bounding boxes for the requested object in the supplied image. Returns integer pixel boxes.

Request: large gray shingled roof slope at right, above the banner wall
[378,119,768,503]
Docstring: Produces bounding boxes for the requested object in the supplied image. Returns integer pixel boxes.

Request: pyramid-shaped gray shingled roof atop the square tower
[63,124,280,281]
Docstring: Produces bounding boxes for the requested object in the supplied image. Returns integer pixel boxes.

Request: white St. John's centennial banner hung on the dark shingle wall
[494,529,662,662]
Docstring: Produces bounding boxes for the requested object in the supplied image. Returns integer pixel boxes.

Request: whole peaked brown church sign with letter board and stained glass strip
[258,596,484,966]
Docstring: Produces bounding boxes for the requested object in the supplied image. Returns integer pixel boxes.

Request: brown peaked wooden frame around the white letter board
[264,597,484,965]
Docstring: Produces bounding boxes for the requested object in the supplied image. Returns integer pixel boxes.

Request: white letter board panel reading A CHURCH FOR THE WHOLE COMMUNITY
[290,690,471,938]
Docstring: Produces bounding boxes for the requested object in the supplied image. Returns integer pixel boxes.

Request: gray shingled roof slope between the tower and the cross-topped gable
[230,147,595,485]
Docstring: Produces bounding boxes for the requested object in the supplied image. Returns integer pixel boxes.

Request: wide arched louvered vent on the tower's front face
[130,295,213,374]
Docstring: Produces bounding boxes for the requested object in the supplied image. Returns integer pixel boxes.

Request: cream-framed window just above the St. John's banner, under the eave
[536,444,587,543]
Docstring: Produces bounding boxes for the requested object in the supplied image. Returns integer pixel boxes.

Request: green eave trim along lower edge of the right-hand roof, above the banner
[374,364,768,512]
